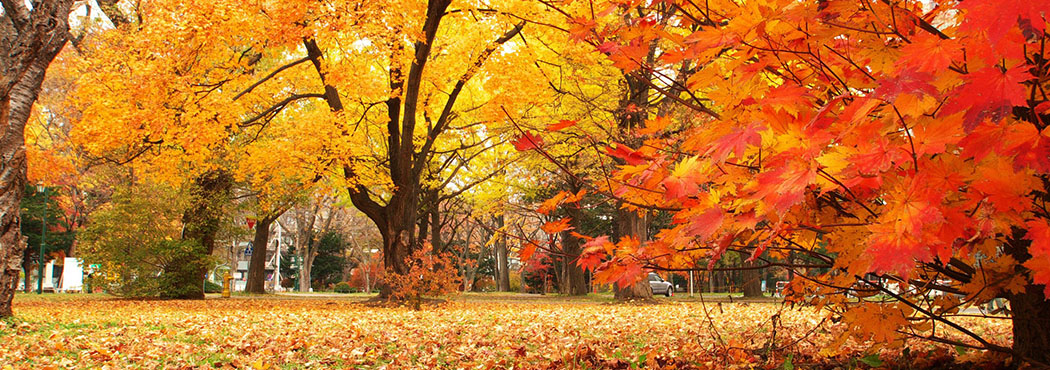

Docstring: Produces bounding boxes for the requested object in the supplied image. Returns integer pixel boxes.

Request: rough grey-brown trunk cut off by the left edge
[0,0,72,317]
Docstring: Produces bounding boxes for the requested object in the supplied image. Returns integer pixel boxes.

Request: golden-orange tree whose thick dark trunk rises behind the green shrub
[55,1,344,297]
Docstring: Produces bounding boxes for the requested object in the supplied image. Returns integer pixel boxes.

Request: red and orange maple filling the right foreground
[573,0,1050,366]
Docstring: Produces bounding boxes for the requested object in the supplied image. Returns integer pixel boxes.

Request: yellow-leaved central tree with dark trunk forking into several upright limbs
[273,0,550,298]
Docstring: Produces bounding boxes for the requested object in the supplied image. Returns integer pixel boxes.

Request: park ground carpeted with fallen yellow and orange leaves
[0,295,1010,369]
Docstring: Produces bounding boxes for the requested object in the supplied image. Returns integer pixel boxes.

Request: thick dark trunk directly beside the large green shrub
[168,170,233,300]
